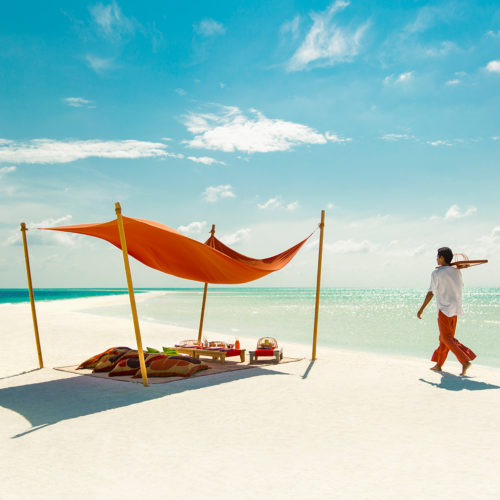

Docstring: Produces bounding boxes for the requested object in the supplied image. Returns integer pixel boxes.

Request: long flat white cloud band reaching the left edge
[0,139,175,163]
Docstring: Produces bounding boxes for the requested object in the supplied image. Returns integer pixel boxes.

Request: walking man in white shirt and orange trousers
[417,247,476,376]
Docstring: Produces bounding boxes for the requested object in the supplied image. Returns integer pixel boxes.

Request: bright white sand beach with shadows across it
[0,292,500,500]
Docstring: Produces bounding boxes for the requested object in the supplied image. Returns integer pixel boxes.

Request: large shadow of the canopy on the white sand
[0,367,289,439]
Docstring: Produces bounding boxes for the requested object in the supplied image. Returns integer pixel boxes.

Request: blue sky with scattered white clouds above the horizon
[0,0,500,291]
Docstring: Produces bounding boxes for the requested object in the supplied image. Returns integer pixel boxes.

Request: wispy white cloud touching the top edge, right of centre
[287,0,367,71]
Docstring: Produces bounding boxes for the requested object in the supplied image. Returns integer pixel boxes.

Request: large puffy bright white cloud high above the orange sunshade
[184,106,350,153]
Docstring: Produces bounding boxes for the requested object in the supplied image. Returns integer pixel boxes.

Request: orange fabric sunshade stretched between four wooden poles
[42,217,311,284]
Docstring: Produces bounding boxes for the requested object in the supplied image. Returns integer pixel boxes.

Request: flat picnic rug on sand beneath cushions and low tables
[54,357,304,384]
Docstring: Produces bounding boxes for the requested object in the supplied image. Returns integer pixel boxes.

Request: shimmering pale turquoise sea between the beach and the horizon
[0,287,500,367]
